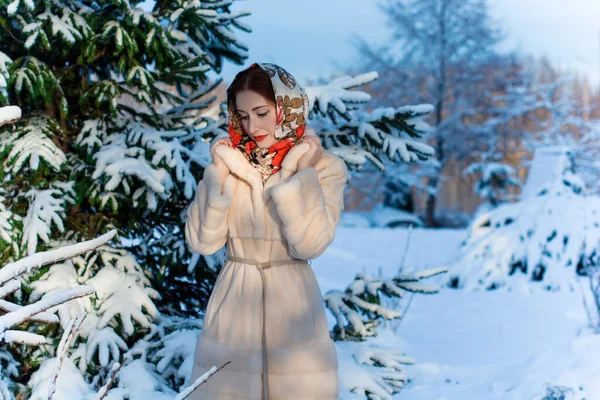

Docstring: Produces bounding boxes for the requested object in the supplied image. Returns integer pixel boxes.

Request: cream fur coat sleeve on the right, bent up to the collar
[272,153,348,260]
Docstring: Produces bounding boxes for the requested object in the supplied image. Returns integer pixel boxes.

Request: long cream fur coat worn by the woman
[185,128,348,400]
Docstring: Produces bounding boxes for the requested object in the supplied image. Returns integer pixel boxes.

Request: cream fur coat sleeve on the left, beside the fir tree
[185,163,234,255]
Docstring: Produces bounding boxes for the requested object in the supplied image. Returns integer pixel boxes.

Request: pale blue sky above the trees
[216,0,600,85]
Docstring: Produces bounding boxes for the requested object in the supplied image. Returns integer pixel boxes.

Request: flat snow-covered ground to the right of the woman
[312,227,600,400]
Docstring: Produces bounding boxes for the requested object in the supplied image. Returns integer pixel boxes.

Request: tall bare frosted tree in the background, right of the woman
[350,0,510,224]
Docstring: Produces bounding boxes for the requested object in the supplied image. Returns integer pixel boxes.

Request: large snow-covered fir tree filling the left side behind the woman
[0,0,249,398]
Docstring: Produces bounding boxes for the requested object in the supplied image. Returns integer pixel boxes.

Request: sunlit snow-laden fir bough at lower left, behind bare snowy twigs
[30,242,159,370]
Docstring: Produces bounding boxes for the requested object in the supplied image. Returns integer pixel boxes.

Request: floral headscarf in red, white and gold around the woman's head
[228,63,309,181]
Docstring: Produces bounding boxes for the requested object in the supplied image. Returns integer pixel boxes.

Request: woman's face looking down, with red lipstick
[235,90,279,149]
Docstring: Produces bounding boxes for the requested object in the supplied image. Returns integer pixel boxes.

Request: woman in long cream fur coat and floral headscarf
[186,63,347,400]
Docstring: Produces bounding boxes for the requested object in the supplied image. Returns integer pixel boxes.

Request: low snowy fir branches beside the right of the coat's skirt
[323,260,448,400]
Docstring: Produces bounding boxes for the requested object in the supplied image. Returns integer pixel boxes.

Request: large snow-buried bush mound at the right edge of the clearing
[449,147,600,290]
